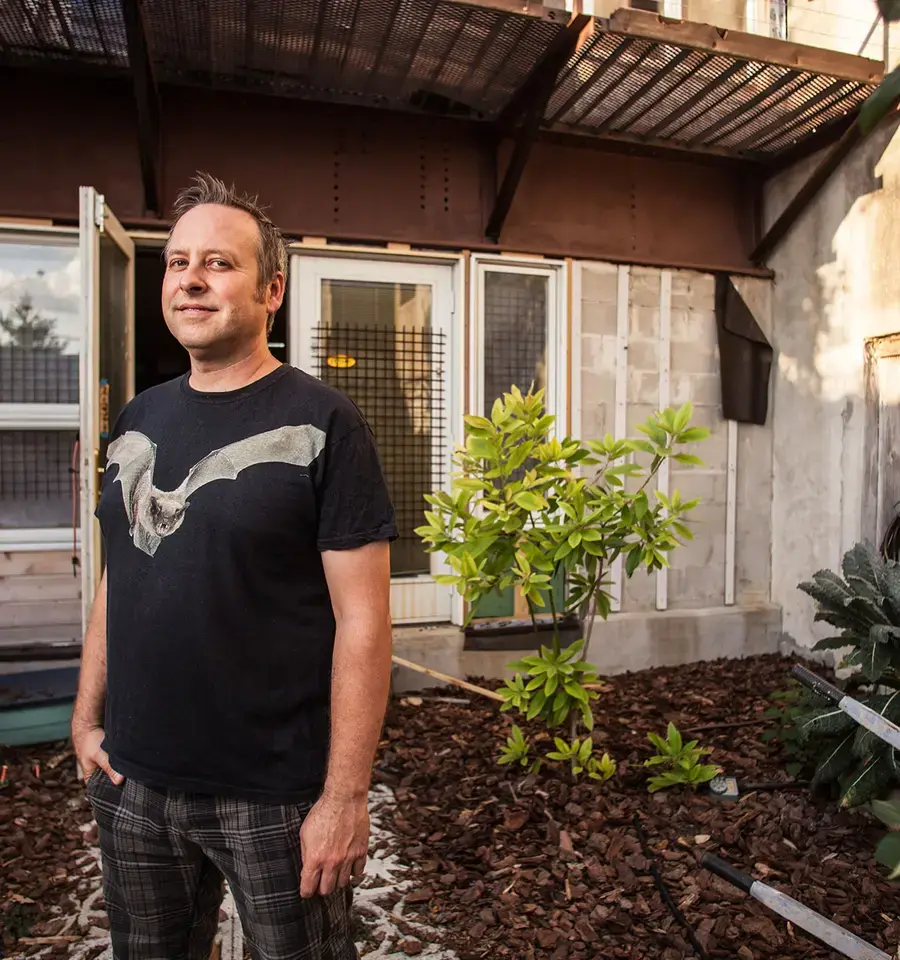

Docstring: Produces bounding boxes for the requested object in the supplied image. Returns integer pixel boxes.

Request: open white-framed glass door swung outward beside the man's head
[79,187,134,629]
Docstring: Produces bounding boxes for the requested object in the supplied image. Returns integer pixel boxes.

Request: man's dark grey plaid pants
[87,771,359,960]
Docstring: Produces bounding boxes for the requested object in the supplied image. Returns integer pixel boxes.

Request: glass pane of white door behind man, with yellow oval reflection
[313,280,445,577]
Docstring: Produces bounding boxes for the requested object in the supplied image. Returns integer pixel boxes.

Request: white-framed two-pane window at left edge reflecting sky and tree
[0,233,82,548]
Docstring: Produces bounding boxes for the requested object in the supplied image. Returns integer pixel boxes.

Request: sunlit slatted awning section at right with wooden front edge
[544,10,883,159]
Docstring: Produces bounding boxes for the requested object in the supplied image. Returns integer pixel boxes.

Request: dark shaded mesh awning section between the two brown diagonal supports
[138,0,562,117]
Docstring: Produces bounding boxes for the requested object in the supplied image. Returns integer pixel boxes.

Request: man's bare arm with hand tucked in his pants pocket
[72,571,123,783]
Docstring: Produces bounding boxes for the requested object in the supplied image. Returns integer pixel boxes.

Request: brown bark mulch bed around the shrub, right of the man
[376,656,900,960]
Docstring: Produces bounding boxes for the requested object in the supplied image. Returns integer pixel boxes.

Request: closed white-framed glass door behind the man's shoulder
[290,255,456,623]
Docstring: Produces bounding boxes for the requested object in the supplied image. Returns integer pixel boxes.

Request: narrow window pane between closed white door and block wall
[484,270,549,416]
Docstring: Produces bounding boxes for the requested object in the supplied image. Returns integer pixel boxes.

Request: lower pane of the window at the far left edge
[0,430,78,530]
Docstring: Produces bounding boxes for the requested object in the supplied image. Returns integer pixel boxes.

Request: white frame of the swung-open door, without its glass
[78,187,134,630]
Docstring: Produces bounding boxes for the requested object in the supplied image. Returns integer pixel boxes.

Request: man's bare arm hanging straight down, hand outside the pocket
[300,542,391,897]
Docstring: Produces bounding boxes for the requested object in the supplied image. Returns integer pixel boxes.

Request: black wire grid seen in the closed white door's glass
[312,323,449,576]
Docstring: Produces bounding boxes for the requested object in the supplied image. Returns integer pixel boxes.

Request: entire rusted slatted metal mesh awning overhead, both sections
[0,0,882,160]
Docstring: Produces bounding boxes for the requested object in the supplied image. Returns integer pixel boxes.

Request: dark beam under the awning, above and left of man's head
[122,0,162,216]
